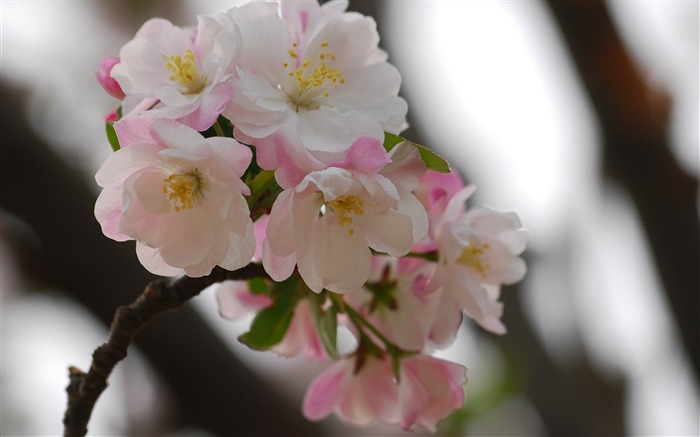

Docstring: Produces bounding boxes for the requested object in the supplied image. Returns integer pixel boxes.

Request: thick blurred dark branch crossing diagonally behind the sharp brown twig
[0,86,320,436]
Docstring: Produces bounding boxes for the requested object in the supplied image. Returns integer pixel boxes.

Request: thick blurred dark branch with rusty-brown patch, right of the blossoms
[547,0,700,379]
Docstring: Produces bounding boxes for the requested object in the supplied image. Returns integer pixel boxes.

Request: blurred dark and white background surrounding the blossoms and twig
[0,0,700,436]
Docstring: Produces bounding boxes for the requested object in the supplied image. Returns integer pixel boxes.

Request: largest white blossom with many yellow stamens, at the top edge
[223,1,407,169]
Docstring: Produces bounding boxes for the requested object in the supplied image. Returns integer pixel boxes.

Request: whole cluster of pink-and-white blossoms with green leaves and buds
[95,0,527,430]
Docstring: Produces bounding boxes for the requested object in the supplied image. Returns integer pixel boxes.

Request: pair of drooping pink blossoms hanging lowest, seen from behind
[303,355,467,432]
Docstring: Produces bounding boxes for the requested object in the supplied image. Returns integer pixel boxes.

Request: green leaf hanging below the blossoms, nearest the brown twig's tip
[238,278,298,350]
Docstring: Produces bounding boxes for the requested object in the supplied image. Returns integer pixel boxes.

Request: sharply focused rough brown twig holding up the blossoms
[63,263,267,436]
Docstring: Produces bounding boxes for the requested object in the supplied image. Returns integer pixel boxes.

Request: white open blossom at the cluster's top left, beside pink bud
[111,13,240,131]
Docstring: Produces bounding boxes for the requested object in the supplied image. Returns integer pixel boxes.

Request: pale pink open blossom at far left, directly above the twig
[95,118,255,277]
